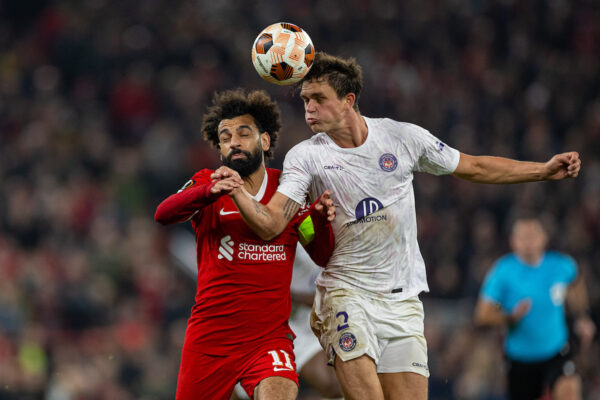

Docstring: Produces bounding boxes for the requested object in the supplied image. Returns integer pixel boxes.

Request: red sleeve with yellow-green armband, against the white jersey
[298,197,335,267]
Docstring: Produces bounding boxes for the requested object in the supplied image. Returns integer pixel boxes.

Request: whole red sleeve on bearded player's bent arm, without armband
[154,170,221,225]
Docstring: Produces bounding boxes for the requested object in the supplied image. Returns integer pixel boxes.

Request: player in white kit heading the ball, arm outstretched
[213,53,581,400]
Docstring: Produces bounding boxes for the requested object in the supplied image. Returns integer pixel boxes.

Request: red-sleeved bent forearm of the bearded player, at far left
[154,183,219,225]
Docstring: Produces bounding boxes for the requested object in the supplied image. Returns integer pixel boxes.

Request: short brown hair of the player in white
[296,51,363,110]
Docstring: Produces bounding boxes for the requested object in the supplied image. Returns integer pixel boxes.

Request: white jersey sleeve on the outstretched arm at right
[406,125,460,175]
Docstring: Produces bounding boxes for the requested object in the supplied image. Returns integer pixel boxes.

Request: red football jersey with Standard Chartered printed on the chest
[157,168,322,355]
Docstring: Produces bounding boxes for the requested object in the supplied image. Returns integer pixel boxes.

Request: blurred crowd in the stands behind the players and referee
[0,0,600,400]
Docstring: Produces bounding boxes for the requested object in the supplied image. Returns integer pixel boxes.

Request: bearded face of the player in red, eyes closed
[218,114,270,177]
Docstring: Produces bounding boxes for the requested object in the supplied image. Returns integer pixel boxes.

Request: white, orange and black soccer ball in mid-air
[252,22,315,85]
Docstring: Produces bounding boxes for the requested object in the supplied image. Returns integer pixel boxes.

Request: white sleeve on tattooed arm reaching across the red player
[277,143,312,204]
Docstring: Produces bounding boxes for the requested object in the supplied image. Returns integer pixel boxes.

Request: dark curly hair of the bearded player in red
[202,89,281,160]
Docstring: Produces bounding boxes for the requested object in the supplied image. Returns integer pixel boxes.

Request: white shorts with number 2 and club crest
[311,286,429,377]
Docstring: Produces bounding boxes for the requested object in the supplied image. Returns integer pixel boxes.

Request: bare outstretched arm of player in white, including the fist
[452,151,581,183]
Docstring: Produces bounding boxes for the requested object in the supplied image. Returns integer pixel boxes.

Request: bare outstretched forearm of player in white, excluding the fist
[454,154,547,184]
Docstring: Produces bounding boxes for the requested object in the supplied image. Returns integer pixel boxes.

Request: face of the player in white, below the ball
[300,80,352,133]
